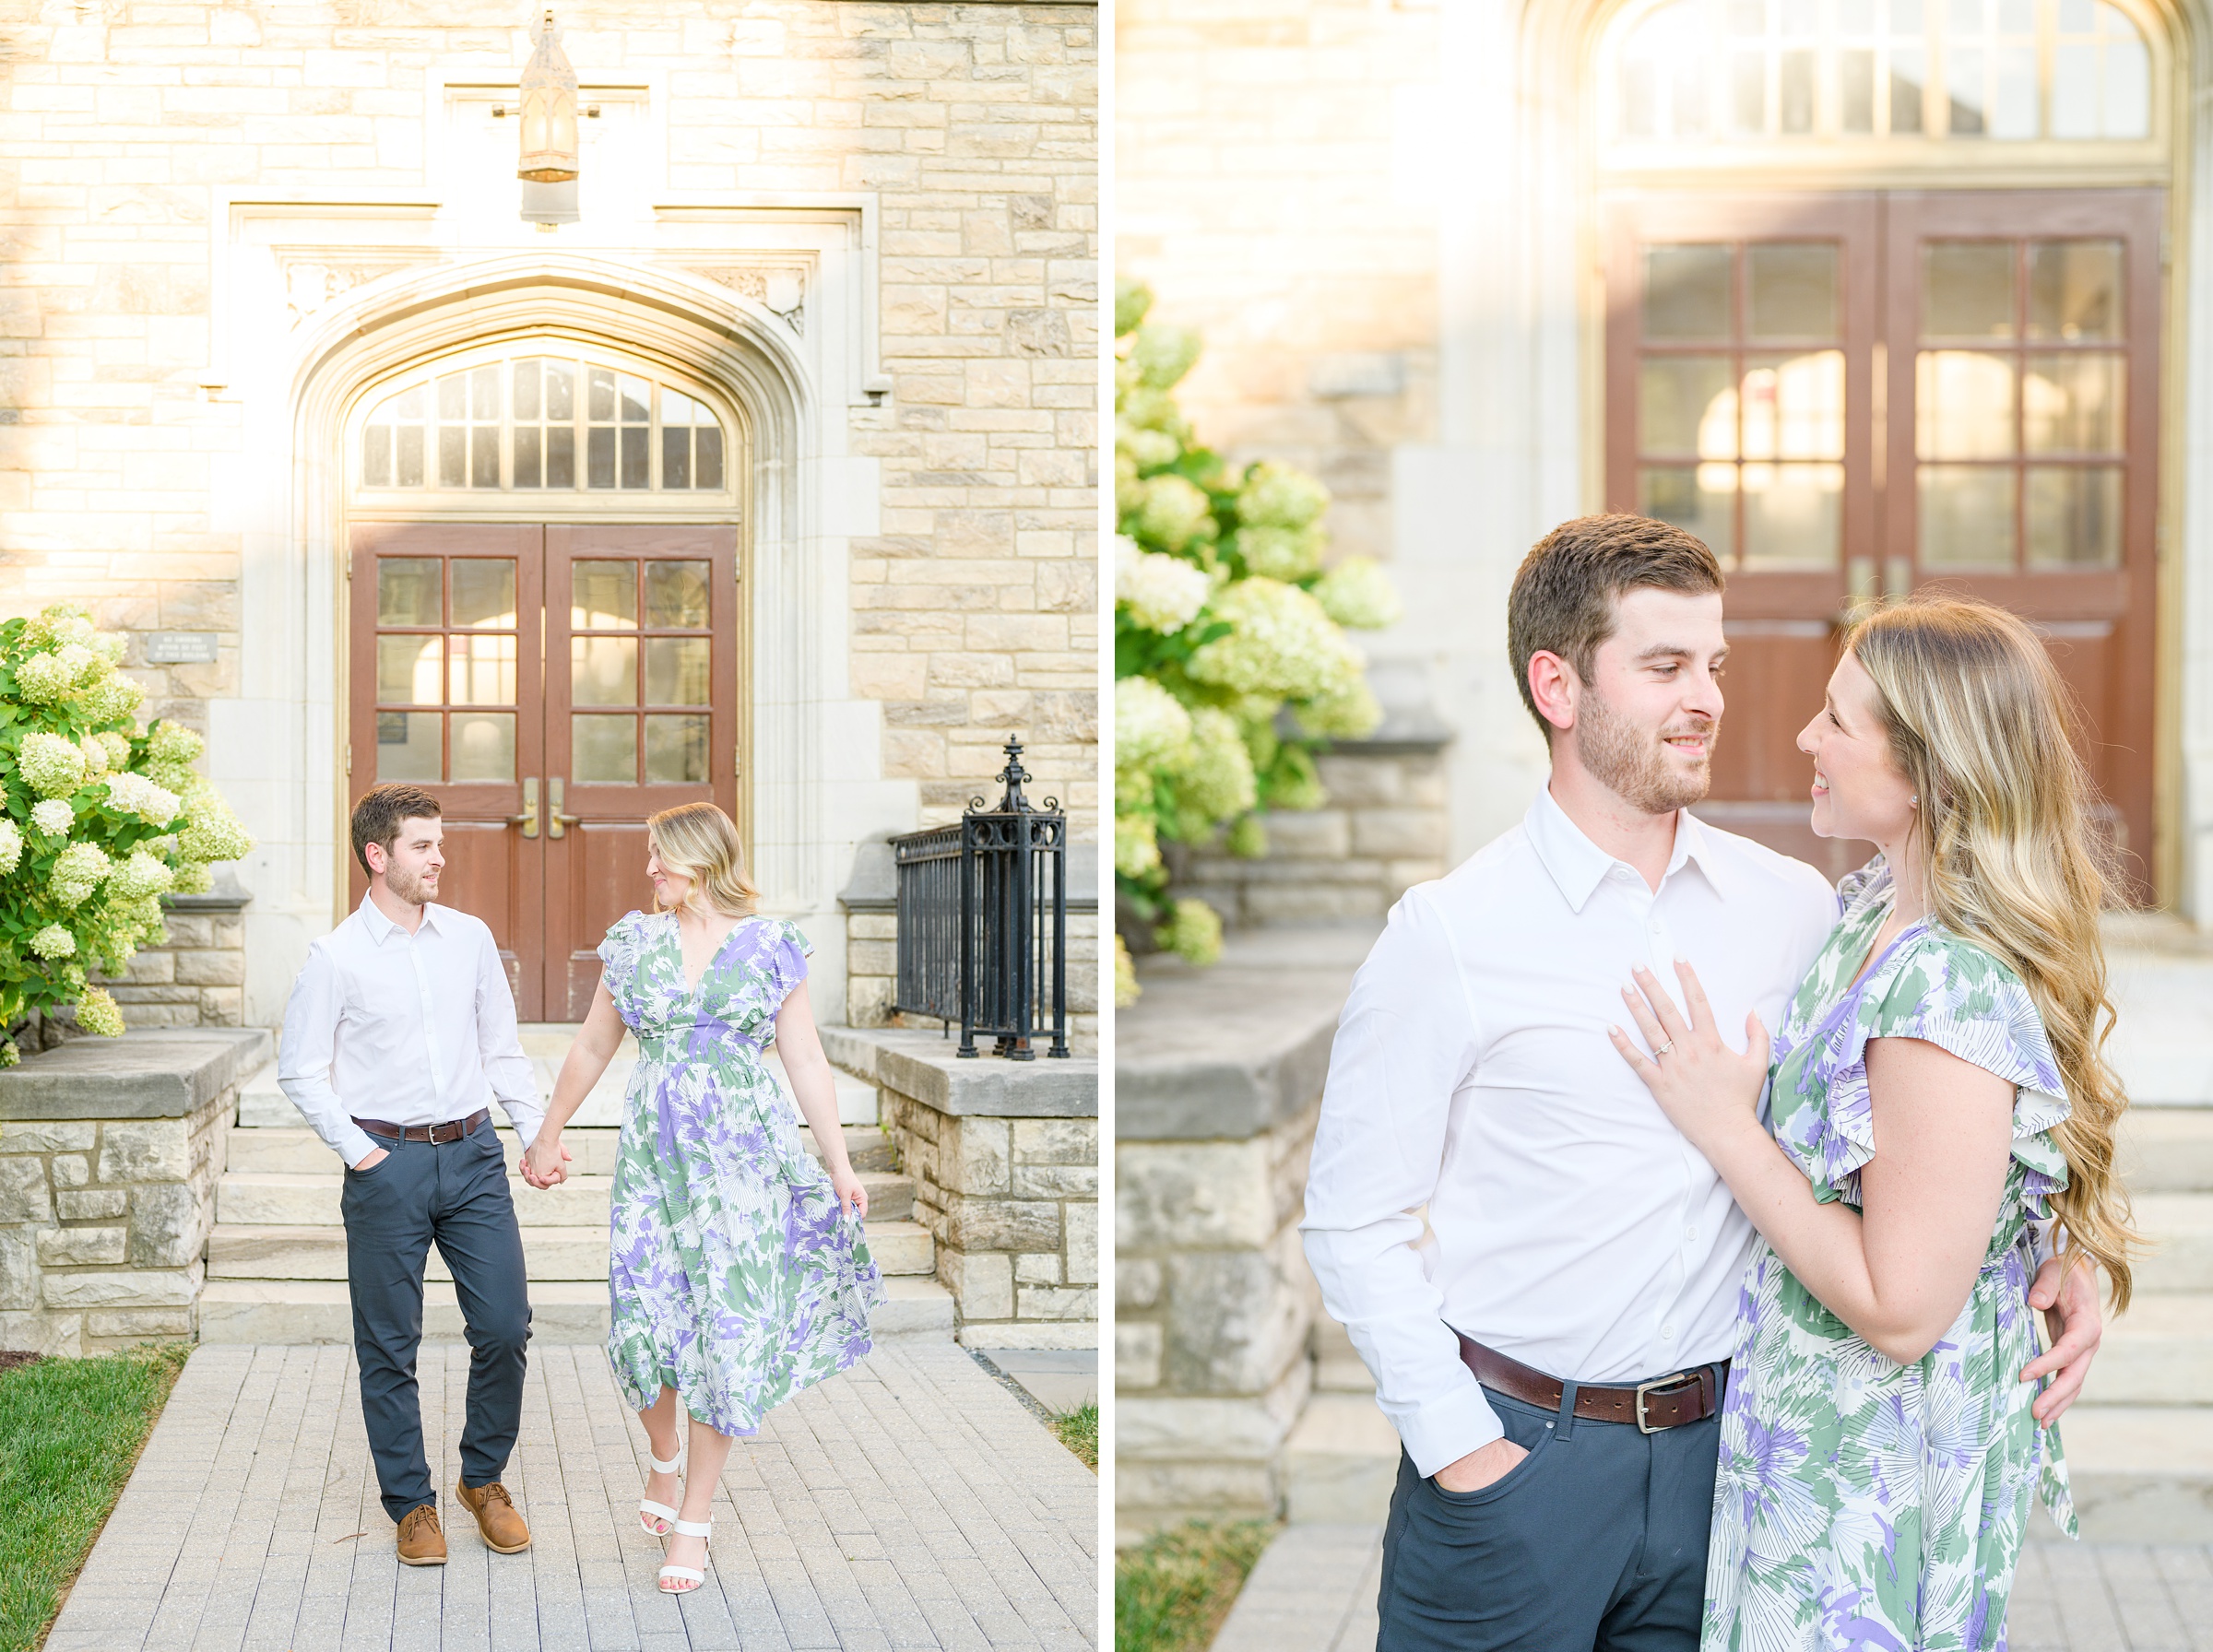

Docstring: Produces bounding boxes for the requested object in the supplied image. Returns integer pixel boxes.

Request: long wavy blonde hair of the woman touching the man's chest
[1843,597,2142,1312]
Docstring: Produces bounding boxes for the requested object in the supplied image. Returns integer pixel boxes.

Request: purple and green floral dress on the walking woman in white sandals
[599,911,883,1435]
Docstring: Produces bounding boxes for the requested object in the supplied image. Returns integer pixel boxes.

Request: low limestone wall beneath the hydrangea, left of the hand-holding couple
[0,1031,270,1353]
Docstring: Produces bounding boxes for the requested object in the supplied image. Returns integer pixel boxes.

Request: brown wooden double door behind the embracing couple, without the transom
[1606,190,2164,903]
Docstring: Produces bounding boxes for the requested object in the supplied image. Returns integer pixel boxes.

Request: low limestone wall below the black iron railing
[825,1029,1100,1349]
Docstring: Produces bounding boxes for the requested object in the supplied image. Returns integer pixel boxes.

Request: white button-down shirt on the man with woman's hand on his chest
[1301,789,1837,1475]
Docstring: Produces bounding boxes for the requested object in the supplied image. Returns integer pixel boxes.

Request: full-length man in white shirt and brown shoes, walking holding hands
[277,785,544,1565]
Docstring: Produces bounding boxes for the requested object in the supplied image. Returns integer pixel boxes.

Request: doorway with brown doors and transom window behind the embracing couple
[1587,0,2178,903]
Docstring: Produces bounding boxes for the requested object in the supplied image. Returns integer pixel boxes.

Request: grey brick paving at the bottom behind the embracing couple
[1213,1524,2213,1652]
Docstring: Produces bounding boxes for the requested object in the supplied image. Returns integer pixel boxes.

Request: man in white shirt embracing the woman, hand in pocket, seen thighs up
[1301,515,2101,1652]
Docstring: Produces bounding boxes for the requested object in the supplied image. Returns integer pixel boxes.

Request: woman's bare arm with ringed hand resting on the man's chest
[1614,964,2014,1364]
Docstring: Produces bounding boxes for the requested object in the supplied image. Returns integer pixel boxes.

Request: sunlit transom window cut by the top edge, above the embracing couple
[1611,0,2151,144]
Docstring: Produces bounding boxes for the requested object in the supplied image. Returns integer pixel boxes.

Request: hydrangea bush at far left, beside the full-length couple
[0,606,253,1066]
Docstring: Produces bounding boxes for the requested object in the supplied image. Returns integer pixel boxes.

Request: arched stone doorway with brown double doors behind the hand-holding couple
[285,256,823,1021]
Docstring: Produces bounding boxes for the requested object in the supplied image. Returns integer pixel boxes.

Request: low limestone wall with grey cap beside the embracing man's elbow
[1113,925,1374,1540]
